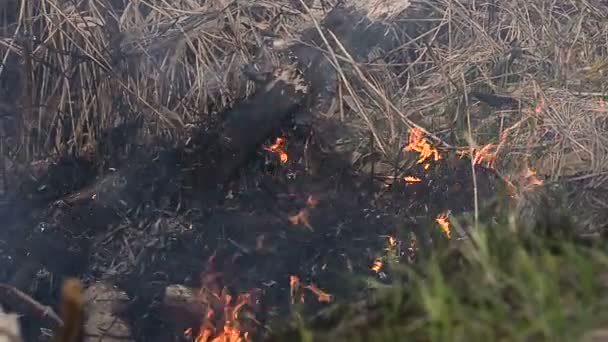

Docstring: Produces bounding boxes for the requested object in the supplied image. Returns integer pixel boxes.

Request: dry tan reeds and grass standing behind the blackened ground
[0,0,608,228]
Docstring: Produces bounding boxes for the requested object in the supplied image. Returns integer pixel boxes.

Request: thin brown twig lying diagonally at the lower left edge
[0,284,63,328]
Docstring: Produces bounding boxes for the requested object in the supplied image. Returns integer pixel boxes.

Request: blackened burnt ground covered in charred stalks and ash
[0,114,504,341]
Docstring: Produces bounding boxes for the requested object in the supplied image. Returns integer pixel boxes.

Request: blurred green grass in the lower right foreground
[275,211,608,342]
